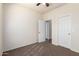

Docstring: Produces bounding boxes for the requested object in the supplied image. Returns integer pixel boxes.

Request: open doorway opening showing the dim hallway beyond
[45,20,52,43]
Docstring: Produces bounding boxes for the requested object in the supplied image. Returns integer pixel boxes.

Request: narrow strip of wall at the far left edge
[0,4,3,56]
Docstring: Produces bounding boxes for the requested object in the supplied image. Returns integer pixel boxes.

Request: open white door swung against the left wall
[38,20,45,42]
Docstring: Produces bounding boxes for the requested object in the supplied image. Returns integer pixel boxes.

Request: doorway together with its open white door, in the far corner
[38,20,52,43]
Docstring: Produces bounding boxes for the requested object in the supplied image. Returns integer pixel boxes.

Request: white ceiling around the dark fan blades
[19,3,65,13]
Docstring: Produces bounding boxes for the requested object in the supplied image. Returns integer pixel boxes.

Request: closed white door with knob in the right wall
[59,15,71,48]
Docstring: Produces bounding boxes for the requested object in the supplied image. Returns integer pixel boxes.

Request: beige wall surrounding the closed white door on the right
[43,4,79,52]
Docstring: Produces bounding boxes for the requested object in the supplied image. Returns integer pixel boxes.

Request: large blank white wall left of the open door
[3,4,42,51]
